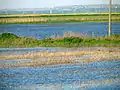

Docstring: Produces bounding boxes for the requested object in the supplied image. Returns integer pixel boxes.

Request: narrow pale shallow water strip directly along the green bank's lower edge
[0,47,120,55]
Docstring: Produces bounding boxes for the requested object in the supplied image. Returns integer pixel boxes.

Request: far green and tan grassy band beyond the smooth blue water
[0,13,120,24]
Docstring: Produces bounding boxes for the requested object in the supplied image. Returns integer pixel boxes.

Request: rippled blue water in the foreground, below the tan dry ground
[0,60,120,90]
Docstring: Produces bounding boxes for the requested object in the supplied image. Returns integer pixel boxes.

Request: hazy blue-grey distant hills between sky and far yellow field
[0,4,120,14]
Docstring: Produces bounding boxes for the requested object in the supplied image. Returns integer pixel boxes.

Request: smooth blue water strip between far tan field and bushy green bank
[0,23,120,39]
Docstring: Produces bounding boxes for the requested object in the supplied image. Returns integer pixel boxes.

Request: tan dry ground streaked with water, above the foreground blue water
[0,47,120,67]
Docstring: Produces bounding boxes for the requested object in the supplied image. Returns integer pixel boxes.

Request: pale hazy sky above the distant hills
[0,0,120,8]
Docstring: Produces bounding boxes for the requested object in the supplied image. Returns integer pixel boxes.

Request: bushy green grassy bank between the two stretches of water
[0,33,120,48]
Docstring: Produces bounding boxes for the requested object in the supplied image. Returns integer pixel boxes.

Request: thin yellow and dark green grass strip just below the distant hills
[0,12,120,18]
